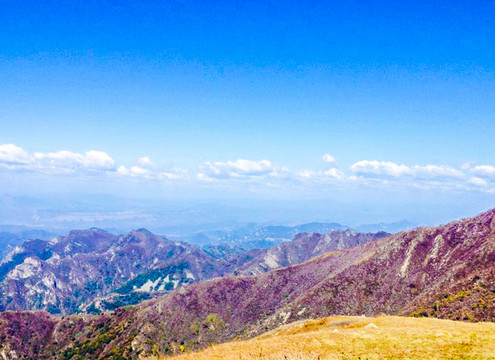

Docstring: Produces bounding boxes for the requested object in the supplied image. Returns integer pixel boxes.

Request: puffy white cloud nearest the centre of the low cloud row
[198,159,274,179]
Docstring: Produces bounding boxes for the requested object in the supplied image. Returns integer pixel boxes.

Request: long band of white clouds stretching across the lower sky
[0,144,495,194]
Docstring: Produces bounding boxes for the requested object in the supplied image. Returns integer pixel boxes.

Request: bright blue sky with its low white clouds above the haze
[0,0,495,225]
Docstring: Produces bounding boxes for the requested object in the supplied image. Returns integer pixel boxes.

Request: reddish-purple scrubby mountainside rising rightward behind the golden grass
[0,210,495,359]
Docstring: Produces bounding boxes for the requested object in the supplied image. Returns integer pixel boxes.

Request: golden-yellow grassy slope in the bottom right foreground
[163,316,495,360]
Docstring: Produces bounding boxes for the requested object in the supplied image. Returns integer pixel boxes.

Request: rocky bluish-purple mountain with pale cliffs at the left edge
[0,229,225,314]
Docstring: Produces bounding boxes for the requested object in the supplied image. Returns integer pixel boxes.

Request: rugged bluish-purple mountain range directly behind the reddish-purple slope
[0,228,384,314]
